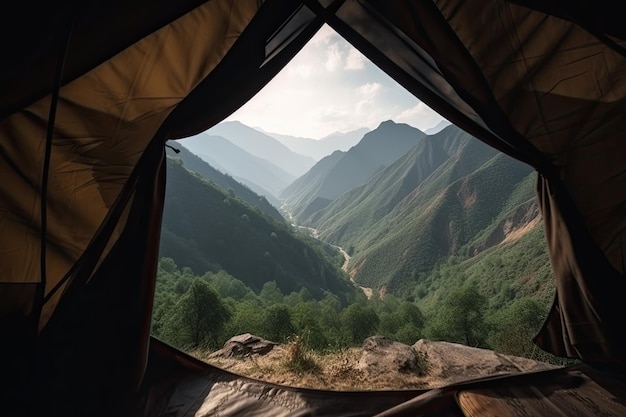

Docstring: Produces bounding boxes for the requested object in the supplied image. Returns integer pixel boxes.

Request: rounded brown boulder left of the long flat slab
[356,336,426,375]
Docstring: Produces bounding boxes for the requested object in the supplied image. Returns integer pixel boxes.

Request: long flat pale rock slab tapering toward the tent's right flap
[413,339,556,384]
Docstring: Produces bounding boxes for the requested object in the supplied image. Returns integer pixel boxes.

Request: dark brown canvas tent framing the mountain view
[0,0,626,416]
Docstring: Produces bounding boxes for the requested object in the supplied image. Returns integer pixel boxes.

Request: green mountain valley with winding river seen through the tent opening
[153,121,556,366]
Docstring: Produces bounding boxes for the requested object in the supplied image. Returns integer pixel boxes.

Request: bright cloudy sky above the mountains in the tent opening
[226,26,443,139]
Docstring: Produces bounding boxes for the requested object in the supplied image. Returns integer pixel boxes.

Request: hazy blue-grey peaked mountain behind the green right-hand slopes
[279,120,425,222]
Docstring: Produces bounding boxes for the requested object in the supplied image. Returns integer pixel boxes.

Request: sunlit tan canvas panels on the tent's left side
[0,1,258,325]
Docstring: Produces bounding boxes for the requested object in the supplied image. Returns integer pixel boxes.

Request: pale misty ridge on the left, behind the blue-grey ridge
[202,122,315,177]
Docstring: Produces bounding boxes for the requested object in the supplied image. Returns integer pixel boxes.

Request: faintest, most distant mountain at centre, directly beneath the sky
[259,127,369,161]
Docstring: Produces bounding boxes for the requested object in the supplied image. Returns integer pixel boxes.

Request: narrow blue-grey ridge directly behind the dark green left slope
[166,143,284,221]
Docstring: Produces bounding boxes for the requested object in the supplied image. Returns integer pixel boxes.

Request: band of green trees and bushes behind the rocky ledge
[152,258,563,364]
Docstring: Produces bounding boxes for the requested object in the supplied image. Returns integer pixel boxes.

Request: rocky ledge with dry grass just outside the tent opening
[204,333,555,390]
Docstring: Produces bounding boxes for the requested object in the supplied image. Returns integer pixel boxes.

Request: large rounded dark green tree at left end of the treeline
[161,279,230,348]
